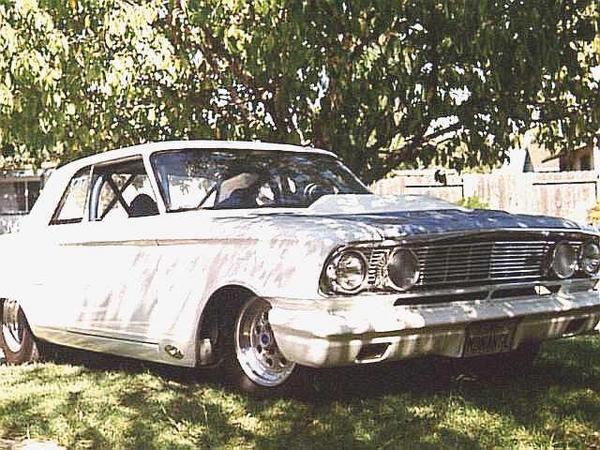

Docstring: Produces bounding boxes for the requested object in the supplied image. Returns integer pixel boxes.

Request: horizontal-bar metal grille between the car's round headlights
[366,240,581,287]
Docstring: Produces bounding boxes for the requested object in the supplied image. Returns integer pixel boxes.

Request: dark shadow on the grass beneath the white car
[35,338,600,405]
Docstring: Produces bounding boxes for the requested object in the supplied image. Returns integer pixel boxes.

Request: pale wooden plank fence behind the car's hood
[371,170,600,222]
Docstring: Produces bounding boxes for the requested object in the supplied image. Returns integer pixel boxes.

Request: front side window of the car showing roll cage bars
[90,158,158,221]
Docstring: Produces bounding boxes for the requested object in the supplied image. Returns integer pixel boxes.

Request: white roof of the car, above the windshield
[62,140,337,171]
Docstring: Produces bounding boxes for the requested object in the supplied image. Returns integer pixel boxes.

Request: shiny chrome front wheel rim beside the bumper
[235,297,296,387]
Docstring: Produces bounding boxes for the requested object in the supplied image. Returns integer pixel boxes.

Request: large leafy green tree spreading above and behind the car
[0,0,600,181]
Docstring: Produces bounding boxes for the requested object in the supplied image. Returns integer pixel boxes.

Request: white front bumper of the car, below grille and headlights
[267,290,600,367]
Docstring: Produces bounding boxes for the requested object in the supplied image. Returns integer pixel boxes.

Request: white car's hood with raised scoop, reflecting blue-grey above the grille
[307,195,581,238]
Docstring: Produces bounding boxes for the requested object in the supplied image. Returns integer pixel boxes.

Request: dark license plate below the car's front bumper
[463,321,517,358]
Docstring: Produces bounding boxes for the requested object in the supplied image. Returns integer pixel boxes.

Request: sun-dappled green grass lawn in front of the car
[0,337,600,449]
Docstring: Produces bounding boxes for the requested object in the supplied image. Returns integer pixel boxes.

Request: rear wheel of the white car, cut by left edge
[0,300,40,364]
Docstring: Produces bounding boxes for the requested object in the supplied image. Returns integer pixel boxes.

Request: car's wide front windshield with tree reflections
[150,149,369,211]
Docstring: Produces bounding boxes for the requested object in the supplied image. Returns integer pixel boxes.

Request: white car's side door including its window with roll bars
[72,157,160,342]
